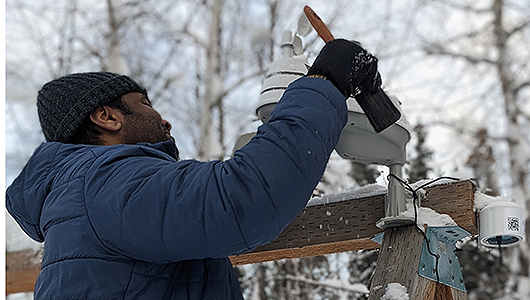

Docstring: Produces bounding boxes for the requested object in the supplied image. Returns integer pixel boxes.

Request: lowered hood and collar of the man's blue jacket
[6,140,178,242]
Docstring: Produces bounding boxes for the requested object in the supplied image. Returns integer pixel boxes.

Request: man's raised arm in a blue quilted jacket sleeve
[86,78,347,262]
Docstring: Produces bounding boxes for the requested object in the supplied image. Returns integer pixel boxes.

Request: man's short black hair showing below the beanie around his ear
[68,97,132,145]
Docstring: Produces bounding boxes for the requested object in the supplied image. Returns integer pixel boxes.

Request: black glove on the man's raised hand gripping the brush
[307,39,381,97]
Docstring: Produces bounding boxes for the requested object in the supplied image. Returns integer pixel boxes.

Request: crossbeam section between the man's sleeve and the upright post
[230,195,385,265]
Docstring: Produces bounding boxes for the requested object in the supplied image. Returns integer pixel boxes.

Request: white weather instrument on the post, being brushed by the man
[245,9,414,229]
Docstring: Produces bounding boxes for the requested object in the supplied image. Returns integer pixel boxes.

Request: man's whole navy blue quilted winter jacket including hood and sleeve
[6,78,347,299]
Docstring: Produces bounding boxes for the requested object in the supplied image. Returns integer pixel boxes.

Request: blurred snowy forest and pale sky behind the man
[5,0,530,300]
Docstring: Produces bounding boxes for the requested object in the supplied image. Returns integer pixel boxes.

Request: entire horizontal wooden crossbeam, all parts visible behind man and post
[6,181,477,294]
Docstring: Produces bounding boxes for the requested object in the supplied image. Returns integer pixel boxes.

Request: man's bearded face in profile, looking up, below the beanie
[118,93,175,144]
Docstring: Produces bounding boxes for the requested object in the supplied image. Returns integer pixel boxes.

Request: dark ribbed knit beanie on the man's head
[37,72,147,143]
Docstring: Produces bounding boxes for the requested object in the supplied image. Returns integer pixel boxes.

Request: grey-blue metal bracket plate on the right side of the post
[418,226,471,292]
